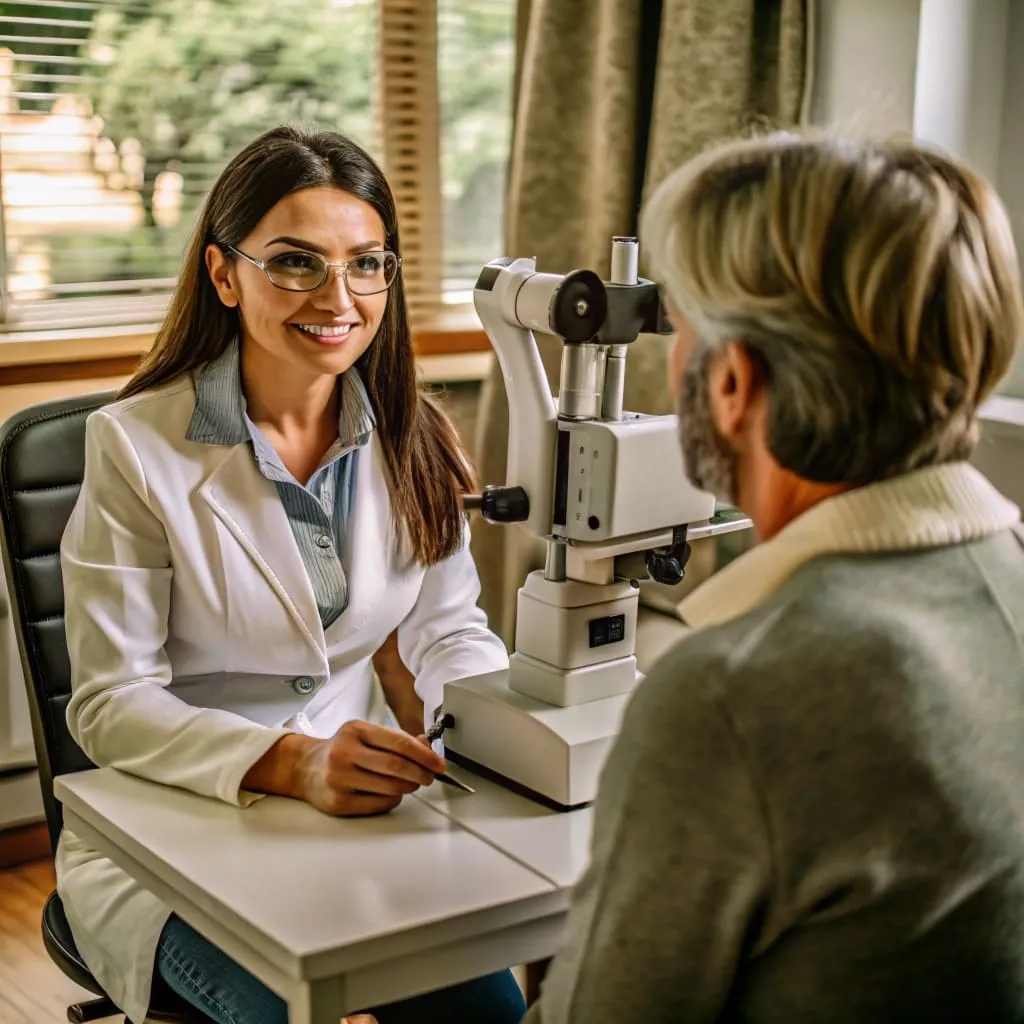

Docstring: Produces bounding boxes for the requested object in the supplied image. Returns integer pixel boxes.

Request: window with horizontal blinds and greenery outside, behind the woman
[0,0,516,331]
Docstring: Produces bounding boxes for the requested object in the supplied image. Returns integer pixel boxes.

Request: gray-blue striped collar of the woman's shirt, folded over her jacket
[185,339,377,449]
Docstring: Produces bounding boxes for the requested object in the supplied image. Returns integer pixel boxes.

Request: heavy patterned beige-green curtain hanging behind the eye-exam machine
[473,0,813,643]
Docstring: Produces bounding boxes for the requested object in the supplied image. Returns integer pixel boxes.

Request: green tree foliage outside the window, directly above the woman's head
[88,0,375,226]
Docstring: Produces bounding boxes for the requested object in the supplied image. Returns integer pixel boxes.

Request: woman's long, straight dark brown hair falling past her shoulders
[120,125,474,565]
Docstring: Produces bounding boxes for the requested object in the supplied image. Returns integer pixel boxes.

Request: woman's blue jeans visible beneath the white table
[154,916,526,1024]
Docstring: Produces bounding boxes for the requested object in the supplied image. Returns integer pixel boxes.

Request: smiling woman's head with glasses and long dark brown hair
[122,127,473,564]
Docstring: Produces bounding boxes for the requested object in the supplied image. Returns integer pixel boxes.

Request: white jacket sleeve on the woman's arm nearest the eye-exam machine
[397,528,509,727]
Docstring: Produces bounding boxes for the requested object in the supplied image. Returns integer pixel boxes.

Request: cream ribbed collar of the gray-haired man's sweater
[679,462,1021,628]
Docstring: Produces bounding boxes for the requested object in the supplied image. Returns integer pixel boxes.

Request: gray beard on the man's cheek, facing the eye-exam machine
[676,342,736,505]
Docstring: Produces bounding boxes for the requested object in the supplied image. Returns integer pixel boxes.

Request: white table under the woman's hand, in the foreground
[54,767,590,1024]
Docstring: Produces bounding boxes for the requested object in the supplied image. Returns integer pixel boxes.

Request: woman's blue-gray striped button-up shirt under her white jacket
[185,341,376,630]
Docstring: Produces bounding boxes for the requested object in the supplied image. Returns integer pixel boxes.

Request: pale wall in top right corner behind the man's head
[811,0,1024,398]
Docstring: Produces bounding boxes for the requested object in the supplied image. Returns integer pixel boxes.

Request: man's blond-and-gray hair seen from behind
[641,133,1024,484]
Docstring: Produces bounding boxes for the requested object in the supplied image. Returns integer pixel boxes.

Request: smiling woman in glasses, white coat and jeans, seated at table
[57,127,524,1024]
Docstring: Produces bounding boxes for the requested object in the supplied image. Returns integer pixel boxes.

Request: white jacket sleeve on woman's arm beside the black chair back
[60,411,289,804]
